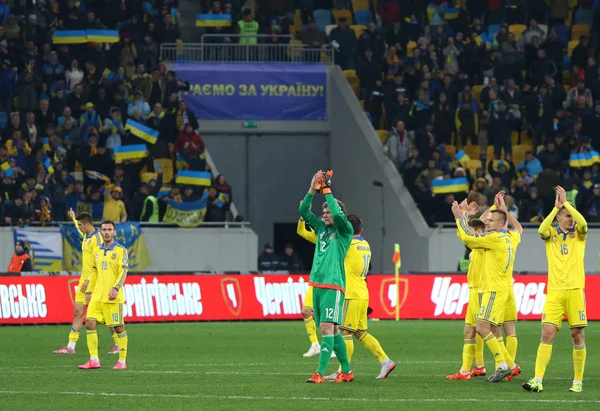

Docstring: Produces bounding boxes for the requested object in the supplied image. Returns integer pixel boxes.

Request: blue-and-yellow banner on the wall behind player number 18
[58,223,152,271]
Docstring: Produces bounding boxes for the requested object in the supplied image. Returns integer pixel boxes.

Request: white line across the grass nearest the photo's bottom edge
[0,390,600,404]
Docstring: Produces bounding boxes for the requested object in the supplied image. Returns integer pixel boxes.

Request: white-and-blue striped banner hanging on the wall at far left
[14,228,63,272]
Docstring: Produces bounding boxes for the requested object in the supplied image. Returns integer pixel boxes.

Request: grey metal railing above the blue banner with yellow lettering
[160,34,333,65]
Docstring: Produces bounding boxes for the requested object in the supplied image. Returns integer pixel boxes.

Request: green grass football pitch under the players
[0,321,600,411]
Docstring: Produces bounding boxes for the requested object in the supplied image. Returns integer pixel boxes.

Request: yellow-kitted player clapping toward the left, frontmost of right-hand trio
[452,201,515,382]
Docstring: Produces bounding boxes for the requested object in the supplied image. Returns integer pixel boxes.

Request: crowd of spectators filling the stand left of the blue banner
[0,0,231,225]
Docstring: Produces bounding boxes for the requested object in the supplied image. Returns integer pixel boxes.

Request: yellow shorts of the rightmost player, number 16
[542,288,587,330]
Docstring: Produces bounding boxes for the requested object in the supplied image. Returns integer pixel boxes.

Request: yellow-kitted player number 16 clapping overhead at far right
[523,186,588,392]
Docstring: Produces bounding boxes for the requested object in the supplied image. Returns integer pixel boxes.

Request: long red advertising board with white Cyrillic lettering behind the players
[0,273,600,325]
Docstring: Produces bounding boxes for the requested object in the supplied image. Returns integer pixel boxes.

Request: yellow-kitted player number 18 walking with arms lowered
[79,220,128,370]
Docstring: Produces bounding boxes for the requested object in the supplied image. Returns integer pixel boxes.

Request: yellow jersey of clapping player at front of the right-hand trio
[456,218,514,293]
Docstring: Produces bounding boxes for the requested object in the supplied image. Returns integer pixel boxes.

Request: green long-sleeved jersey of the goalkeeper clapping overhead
[298,193,354,292]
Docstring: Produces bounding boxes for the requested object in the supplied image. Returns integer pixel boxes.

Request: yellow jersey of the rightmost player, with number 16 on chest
[542,227,587,291]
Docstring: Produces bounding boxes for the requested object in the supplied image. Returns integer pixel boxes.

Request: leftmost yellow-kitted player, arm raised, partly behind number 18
[53,209,119,354]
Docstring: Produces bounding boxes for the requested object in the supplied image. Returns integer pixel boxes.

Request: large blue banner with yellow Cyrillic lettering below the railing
[175,62,327,121]
